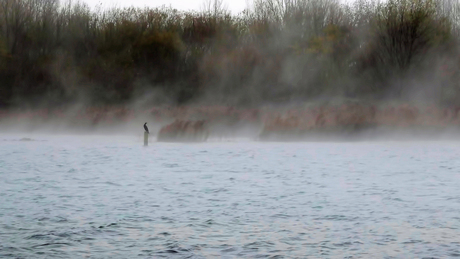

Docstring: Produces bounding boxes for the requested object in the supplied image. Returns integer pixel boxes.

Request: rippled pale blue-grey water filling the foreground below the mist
[0,135,460,258]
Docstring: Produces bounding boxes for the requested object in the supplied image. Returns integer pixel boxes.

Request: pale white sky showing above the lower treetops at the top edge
[83,0,247,14]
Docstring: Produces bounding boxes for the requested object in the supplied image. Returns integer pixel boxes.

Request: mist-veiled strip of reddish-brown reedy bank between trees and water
[0,100,460,143]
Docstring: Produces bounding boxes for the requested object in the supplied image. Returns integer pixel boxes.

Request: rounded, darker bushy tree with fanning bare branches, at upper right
[365,0,451,94]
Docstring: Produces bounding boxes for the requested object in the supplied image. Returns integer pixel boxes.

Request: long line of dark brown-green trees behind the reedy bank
[0,0,460,107]
